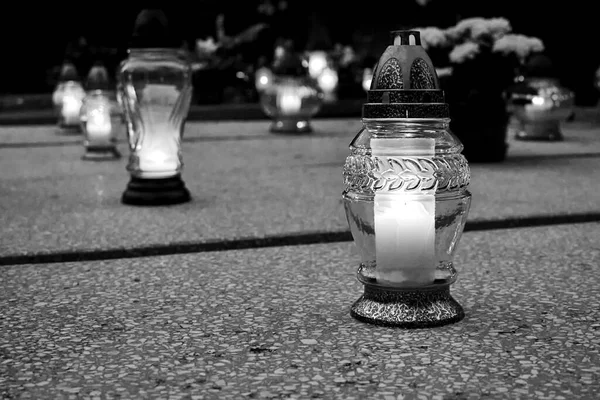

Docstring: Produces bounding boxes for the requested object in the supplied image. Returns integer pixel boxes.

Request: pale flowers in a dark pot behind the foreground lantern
[415,18,544,162]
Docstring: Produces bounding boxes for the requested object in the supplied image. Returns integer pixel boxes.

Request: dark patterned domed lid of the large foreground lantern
[363,31,450,119]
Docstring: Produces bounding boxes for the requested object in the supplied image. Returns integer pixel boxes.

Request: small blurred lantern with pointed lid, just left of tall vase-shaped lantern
[80,62,124,160]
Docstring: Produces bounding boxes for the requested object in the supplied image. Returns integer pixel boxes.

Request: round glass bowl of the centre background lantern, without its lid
[260,76,323,133]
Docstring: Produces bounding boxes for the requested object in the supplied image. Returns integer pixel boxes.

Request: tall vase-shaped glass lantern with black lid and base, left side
[118,10,192,205]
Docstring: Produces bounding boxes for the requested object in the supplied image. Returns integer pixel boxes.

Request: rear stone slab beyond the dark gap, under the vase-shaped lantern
[0,128,600,256]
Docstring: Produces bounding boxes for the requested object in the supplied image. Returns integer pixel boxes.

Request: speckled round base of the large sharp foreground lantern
[350,284,465,329]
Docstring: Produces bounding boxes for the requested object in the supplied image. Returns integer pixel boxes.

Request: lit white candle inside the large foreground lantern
[371,138,437,287]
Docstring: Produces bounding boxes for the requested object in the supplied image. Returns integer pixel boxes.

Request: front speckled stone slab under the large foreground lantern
[0,223,600,400]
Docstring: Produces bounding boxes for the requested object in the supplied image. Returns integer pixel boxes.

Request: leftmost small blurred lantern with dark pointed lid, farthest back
[52,61,85,132]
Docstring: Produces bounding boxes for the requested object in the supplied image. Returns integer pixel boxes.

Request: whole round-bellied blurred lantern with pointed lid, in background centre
[260,43,323,133]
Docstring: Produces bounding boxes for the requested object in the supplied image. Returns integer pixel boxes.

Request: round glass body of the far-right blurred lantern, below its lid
[508,78,574,141]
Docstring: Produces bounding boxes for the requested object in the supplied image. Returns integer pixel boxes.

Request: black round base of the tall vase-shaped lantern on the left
[121,175,191,206]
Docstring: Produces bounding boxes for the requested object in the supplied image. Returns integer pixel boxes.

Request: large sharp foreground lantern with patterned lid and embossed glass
[343,31,471,328]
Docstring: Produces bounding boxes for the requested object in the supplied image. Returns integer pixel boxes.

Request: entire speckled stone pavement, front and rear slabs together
[0,120,600,400]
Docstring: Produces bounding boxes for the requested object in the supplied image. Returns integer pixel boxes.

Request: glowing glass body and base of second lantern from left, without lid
[80,90,123,161]
